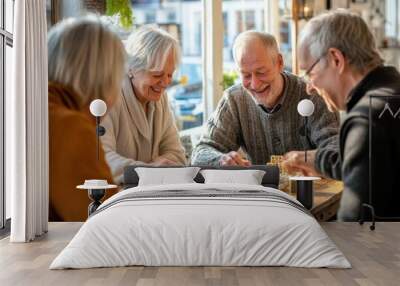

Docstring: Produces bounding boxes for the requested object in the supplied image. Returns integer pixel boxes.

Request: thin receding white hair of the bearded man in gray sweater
[232,30,279,63]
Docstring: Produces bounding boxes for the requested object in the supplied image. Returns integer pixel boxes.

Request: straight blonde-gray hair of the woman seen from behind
[47,15,125,104]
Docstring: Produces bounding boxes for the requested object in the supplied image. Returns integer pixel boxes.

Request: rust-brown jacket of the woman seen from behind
[49,83,116,221]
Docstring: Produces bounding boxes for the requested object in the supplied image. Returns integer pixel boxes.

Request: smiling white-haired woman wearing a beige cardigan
[102,25,186,183]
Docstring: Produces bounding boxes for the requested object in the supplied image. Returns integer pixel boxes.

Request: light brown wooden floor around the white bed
[0,222,400,286]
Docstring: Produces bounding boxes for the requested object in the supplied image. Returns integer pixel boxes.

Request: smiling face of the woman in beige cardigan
[132,52,175,104]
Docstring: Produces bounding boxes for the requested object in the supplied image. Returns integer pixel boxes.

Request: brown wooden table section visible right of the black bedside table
[289,179,343,221]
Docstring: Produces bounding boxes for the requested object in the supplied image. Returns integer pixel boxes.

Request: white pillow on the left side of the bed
[135,167,200,186]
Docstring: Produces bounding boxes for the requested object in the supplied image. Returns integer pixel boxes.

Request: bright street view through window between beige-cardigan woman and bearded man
[133,0,203,130]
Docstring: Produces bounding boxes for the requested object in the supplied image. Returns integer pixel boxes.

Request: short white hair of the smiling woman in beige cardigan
[125,25,181,71]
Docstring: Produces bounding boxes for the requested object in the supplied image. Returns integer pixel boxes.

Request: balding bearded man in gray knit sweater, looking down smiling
[192,31,339,177]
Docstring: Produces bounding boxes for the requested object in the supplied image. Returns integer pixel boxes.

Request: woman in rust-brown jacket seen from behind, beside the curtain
[48,17,125,221]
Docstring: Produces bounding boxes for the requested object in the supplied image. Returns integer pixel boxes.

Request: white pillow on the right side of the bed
[200,169,265,185]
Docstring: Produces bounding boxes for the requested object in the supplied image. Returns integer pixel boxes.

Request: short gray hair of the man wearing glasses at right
[299,9,384,72]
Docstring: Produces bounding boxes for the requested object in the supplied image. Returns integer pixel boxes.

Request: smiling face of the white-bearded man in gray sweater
[236,38,283,108]
